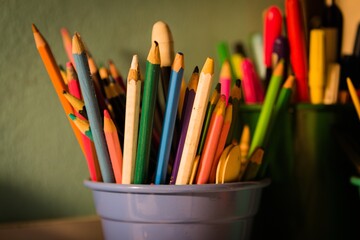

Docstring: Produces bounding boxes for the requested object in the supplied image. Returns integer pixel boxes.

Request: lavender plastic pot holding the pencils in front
[84,179,270,240]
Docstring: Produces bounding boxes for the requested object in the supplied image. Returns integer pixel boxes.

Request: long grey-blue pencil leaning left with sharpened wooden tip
[72,33,115,183]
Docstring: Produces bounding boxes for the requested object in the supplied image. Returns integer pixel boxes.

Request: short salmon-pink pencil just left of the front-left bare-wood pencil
[104,110,122,183]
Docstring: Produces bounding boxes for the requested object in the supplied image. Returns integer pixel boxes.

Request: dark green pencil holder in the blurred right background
[239,104,360,240]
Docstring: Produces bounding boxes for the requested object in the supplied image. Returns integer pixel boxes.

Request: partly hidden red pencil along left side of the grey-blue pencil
[66,62,102,182]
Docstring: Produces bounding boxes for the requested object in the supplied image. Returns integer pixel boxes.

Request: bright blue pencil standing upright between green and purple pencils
[155,53,184,184]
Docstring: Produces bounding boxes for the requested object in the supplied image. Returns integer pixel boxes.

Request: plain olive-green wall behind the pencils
[0,0,284,222]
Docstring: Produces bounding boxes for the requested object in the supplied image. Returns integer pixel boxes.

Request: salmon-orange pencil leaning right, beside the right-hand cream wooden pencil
[196,95,226,184]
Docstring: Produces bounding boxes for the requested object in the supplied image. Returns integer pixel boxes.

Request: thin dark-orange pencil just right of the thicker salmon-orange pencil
[209,100,233,183]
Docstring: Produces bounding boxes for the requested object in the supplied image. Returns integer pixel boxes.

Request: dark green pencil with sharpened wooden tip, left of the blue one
[134,42,160,184]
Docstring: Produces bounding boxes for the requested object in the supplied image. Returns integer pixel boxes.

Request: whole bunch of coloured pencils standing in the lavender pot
[32,16,294,185]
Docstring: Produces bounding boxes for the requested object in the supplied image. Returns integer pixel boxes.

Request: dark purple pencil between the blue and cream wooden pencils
[170,66,199,184]
